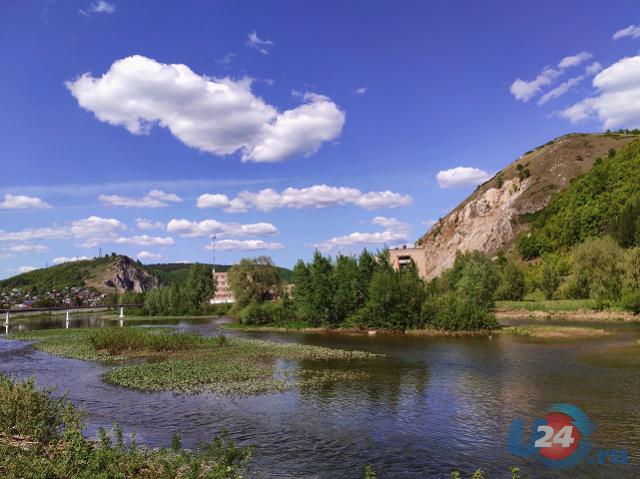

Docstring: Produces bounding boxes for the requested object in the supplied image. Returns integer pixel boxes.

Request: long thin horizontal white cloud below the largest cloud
[197,185,413,213]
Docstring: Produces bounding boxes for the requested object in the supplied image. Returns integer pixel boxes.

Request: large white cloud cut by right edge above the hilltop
[558,56,640,129]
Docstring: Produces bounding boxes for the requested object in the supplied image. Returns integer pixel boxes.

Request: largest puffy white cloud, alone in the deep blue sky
[66,55,345,162]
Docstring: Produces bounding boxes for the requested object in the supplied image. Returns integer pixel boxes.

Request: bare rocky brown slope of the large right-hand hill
[415,132,639,278]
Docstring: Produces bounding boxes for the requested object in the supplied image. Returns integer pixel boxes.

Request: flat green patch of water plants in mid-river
[8,327,379,395]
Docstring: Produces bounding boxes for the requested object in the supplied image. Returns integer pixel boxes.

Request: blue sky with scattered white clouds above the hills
[0,0,640,277]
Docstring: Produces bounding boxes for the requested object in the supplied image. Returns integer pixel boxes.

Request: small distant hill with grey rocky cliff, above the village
[0,255,160,293]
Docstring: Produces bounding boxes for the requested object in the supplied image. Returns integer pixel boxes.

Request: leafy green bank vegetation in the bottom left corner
[0,375,252,479]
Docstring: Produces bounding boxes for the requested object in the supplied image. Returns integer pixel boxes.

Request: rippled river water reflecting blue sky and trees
[0,316,640,479]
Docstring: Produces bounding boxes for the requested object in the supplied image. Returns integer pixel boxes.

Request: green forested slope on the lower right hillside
[517,140,640,259]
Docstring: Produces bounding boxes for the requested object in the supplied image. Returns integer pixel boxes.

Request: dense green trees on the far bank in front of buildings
[229,250,524,330]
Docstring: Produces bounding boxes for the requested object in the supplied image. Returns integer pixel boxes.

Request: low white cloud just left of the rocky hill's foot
[314,216,411,252]
